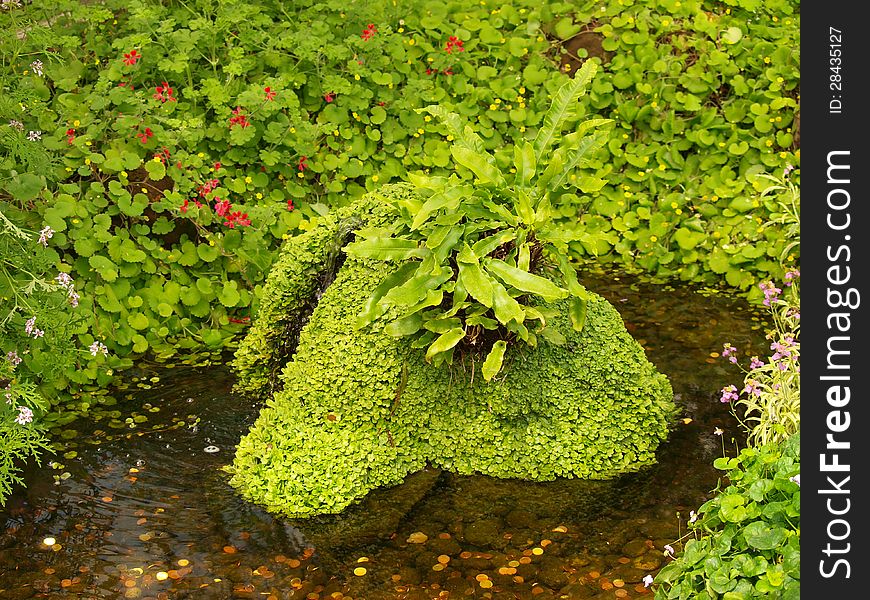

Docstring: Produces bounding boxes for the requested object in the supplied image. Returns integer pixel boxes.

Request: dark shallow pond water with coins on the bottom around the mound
[0,275,767,600]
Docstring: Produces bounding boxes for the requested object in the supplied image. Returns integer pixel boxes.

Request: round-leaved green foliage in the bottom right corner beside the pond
[655,434,800,600]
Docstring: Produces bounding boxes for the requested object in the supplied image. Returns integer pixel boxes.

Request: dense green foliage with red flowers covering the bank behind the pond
[0,0,800,408]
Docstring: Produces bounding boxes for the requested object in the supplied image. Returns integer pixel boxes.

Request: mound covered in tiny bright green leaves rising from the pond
[229,185,674,517]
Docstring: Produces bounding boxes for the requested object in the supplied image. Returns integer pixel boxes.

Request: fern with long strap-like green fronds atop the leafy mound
[346,61,611,381]
